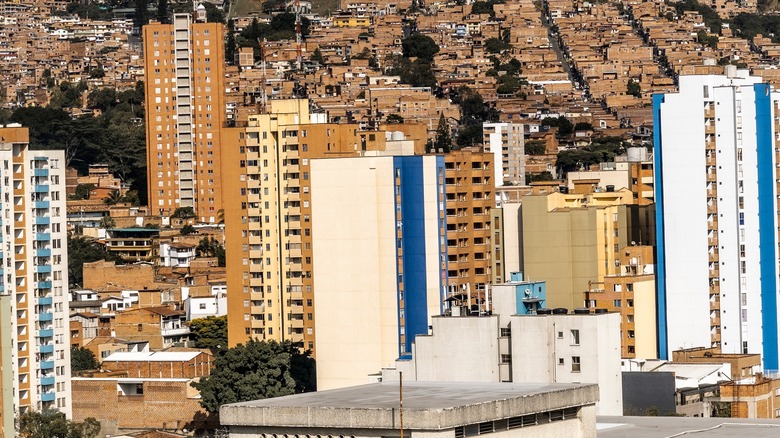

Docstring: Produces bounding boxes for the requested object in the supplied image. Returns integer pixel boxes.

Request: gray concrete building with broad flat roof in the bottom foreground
[220,382,598,438]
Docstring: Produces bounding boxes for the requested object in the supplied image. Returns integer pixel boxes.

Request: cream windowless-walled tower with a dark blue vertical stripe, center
[312,155,447,389]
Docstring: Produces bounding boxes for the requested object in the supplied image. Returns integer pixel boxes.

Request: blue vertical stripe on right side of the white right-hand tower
[753,84,778,371]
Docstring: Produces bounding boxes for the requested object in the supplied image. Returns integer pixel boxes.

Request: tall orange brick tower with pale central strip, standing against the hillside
[143,14,225,222]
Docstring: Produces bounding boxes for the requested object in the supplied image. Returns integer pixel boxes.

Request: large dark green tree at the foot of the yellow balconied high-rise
[192,340,317,412]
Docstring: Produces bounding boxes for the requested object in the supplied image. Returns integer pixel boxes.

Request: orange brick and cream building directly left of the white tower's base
[584,246,658,359]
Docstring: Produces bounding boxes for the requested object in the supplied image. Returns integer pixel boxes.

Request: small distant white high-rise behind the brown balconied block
[482,122,525,186]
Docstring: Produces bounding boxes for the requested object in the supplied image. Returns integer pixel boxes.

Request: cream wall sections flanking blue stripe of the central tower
[311,156,442,390]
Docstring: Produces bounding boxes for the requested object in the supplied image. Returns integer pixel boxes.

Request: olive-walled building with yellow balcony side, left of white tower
[520,188,654,309]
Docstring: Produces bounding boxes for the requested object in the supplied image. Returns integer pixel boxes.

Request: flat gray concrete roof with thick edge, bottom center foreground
[220,381,599,430]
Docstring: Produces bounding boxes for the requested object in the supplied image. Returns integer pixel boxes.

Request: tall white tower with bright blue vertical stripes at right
[653,66,780,370]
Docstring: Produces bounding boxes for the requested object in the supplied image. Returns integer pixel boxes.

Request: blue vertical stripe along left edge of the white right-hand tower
[653,94,669,360]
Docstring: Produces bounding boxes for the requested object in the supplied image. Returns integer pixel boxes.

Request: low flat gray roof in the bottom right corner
[596,417,780,438]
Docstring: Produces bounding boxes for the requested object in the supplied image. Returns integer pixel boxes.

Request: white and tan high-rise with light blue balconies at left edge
[0,125,71,436]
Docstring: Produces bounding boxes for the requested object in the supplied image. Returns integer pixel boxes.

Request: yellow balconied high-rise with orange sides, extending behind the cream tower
[222,99,426,349]
